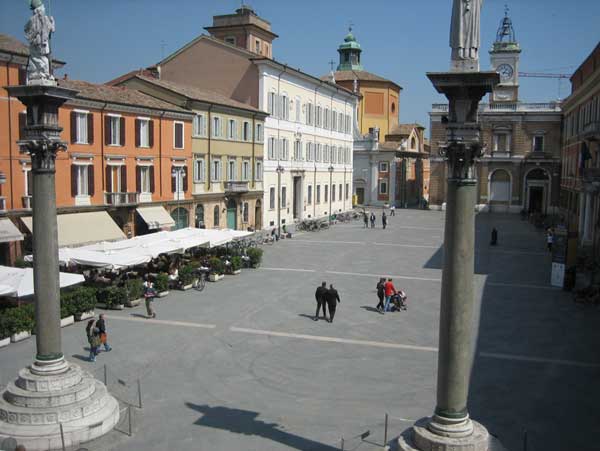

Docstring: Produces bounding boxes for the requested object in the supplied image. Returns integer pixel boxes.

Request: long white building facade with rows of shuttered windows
[255,59,358,228]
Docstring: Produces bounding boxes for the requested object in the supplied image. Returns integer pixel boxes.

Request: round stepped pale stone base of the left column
[0,359,119,451]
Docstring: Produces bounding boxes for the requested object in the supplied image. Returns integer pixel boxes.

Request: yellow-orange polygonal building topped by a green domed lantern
[322,29,402,143]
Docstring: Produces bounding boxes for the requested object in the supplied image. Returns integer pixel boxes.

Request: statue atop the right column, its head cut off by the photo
[450,0,483,61]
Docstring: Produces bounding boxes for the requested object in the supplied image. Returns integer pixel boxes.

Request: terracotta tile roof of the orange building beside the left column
[58,80,191,114]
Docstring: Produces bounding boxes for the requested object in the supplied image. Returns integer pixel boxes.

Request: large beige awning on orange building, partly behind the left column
[21,211,126,247]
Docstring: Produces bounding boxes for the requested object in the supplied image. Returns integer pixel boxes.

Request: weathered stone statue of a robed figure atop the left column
[25,0,56,84]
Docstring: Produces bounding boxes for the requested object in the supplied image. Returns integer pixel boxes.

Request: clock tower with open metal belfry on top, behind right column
[490,7,521,102]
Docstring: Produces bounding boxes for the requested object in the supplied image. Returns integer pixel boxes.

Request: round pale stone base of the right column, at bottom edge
[398,417,497,451]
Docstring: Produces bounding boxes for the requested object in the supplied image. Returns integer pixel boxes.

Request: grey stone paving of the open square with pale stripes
[0,210,600,451]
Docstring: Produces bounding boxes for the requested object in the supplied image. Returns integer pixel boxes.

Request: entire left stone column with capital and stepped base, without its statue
[0,82,119,451]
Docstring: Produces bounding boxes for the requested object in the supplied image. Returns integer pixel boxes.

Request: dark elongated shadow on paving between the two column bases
[185,402,339,451]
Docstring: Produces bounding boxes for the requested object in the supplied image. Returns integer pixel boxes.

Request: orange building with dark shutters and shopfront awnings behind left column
[0,35,194,263]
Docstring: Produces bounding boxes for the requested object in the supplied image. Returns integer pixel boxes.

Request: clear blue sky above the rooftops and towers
[0,0,600,137]
